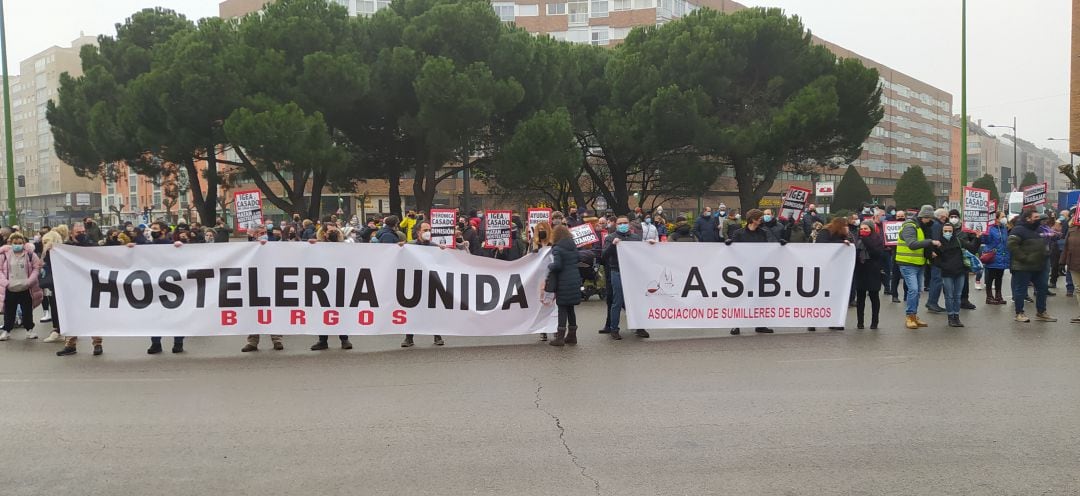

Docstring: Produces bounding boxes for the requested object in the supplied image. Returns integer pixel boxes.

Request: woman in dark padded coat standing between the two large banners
[544,226,581,346]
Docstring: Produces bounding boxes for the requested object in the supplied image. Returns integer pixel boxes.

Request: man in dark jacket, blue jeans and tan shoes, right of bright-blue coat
[1005,207,1057,322]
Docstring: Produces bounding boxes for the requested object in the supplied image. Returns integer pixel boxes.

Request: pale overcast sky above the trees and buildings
[4,0,1071,150]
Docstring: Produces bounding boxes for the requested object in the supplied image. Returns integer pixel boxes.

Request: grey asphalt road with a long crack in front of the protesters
[0,283,1080,496]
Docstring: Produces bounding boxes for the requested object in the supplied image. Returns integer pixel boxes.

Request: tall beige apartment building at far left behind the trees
[0,36,102,227]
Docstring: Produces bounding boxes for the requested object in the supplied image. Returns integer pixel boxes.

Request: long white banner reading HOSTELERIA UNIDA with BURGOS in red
[52,243,556,336]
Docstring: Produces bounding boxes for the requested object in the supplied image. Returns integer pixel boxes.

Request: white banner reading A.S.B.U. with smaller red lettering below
[618,243,855,329]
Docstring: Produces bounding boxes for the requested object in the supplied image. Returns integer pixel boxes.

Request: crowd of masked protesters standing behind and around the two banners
[0,199,1080,357]
